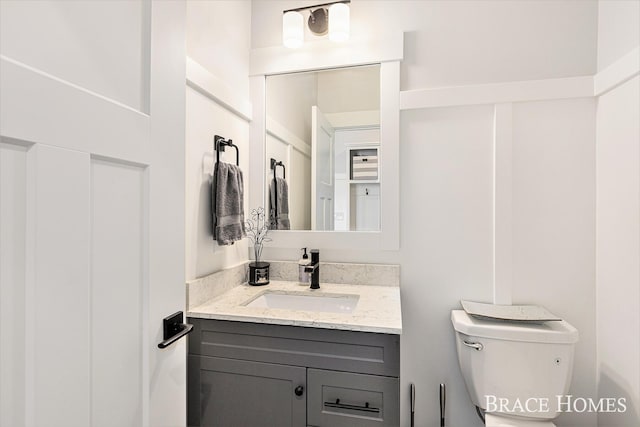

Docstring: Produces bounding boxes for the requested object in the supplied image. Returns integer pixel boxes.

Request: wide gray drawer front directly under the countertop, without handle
[189,318,400,377]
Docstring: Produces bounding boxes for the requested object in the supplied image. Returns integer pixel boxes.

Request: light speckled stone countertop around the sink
[187,280,402,335]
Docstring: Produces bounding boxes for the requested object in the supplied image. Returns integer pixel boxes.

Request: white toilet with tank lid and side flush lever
[451,310,578,427]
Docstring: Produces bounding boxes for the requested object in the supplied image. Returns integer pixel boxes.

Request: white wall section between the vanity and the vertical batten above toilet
[400,106,493,427]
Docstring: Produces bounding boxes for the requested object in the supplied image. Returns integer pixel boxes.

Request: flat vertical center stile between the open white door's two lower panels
[25,144,90,427]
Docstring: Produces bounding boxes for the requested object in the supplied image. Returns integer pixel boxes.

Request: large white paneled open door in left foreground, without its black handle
[0,0,186,427]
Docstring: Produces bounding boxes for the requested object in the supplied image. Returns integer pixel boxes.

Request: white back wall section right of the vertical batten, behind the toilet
[511,98,596,426]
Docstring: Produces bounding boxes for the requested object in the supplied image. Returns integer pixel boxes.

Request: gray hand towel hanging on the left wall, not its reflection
[211,162,247,245]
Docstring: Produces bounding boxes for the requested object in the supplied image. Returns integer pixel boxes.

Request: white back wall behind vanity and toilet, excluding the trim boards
[252,1,597,427]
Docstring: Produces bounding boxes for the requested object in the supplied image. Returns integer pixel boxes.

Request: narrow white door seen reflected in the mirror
[311,105,335,230]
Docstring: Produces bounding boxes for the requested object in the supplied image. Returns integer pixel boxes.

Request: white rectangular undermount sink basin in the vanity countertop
[245,291,359,313]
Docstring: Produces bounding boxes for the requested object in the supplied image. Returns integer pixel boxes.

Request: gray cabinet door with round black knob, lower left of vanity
[188,356,307,427]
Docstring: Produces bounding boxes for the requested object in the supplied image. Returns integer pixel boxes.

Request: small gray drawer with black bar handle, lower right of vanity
[307,369,400,427]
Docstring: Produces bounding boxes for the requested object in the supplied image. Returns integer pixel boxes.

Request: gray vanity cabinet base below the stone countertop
[188,318,400,427]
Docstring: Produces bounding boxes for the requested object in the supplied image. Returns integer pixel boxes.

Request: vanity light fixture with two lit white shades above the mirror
[282,0,351,48]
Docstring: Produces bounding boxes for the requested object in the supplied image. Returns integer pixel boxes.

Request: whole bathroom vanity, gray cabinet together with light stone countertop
[188,270,402,427]
